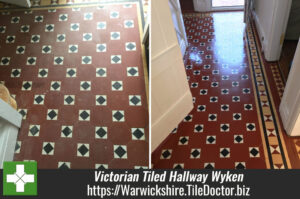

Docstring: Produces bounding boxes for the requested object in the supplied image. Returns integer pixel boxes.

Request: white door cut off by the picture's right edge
[279,40,300,136]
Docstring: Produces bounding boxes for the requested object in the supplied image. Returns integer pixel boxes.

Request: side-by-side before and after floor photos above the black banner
[0,0,300,169]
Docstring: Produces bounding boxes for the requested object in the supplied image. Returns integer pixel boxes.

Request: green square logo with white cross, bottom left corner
[3,162,37,196]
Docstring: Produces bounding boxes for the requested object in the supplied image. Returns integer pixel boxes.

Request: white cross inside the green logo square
[6,164,34,192]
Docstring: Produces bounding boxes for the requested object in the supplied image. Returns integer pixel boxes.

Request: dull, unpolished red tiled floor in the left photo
[0,0,148,169]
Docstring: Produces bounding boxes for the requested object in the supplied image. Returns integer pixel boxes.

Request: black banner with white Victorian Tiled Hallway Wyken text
[0,170,300,199]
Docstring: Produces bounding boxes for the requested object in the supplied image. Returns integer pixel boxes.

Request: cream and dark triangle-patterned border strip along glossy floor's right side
[246,23,290,169]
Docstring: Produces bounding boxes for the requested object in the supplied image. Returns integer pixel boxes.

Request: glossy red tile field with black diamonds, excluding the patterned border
[152,12,268,169]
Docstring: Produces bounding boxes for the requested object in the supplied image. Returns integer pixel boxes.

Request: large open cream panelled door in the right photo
[150,0,193,151]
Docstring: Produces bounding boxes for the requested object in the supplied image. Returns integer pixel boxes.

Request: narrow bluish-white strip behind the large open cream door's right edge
[169,0,188,56]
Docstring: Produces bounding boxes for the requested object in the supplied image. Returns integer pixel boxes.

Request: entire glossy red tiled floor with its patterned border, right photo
[152,12,300,169]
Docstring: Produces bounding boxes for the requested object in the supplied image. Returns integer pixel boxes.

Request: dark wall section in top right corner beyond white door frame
[285,0,300,40]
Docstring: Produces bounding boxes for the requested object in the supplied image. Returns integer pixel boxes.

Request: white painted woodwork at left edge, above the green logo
[0,99,22,168]
